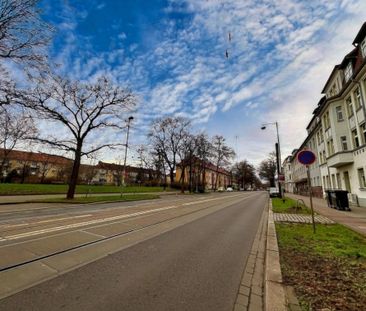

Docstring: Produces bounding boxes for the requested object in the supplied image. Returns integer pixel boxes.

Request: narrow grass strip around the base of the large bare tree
[28,194,159,204]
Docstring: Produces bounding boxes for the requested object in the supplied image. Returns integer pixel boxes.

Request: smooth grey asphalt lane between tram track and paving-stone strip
[0,193,267,311]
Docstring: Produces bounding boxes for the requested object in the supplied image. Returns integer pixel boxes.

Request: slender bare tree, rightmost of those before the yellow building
[212,135,235,190]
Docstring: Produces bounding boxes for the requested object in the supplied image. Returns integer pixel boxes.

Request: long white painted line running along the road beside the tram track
[0,194,254,242]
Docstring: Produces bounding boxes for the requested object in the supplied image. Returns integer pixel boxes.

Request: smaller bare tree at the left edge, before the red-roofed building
[0,107,37,177]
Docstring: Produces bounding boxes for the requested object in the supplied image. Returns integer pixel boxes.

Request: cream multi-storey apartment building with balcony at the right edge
[291,23,366,207]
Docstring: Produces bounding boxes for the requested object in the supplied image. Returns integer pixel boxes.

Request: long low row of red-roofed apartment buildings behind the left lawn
[0,149,164,185]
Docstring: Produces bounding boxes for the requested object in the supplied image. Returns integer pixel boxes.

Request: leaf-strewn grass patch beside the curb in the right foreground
[276,224,366,311]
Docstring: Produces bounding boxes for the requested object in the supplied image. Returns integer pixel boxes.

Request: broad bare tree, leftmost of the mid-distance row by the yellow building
[148,117,191,183]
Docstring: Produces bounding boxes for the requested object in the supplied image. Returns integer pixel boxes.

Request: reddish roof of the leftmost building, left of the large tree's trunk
[0,149,73,165]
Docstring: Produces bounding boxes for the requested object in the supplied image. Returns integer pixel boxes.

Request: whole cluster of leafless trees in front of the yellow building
[149,117,235,191]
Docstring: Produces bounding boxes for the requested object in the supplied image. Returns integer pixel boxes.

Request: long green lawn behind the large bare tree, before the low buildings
[0,183,174,195]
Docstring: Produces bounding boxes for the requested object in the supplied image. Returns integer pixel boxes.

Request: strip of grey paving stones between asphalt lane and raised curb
[233,207,268,311]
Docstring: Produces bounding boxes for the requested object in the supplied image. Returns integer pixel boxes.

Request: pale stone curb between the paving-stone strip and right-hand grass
[264,200,288,311]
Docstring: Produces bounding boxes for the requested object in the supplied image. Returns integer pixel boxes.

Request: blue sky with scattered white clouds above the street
[40,0,366,165]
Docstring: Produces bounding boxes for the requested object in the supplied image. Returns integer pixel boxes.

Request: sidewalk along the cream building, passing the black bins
[286,193,366,236]
